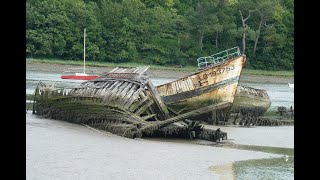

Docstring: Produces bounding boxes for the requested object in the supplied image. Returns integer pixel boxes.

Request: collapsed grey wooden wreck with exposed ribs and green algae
[33,67,231,141]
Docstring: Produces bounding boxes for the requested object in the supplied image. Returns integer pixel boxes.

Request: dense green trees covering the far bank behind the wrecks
[26,0,294,70]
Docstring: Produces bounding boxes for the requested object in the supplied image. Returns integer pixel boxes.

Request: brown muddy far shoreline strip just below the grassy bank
[26,62,294,84]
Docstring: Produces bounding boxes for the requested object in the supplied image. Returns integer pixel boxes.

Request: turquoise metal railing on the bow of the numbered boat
[197,47,241,69]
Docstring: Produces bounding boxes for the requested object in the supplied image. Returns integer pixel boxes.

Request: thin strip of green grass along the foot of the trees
[26,59,294,77]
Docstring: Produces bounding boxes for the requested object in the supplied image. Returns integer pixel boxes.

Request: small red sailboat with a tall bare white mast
[61,29,99,80]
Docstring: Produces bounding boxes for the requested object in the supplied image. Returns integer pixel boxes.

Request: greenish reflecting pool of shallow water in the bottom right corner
[209,144,294,180]
